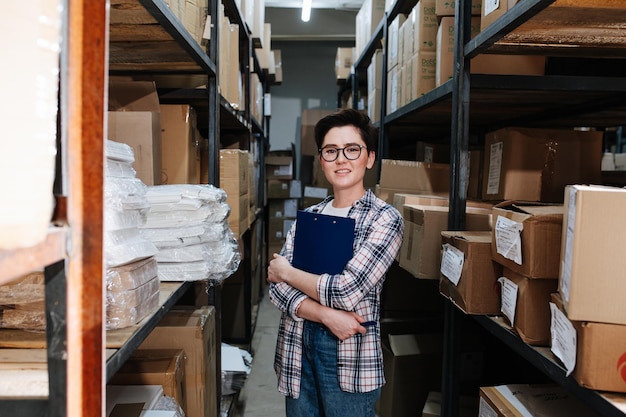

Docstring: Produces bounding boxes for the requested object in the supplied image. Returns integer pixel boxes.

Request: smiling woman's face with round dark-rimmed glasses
[320,126,375,193]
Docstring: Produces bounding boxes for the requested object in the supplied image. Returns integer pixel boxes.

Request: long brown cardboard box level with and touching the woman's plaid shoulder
[378,159,450,204]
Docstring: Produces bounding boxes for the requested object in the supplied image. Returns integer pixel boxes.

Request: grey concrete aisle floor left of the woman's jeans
[237,286,285,417]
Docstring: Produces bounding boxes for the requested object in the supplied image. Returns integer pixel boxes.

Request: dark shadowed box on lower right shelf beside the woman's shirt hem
[376,334,443,417]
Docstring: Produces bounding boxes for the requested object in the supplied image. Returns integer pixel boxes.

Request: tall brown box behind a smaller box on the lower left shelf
[139,306,219,417]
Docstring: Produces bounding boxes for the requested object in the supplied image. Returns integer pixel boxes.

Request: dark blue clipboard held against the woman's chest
[291,210,355,275]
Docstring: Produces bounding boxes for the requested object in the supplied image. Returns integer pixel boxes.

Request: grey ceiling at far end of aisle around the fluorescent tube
[265,0,363,41]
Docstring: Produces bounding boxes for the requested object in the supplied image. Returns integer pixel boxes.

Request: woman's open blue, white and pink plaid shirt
[269,190,404,398]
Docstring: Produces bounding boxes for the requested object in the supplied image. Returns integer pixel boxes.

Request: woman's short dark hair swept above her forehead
[315,109,378,157]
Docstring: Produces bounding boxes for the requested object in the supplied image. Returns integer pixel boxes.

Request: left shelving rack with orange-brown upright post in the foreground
[0,0,268,417]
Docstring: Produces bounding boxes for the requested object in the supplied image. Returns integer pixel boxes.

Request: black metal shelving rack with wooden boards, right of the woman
[348,0,626,416]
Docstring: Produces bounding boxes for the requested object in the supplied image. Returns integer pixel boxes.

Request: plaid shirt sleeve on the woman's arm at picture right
[317,206,404,311]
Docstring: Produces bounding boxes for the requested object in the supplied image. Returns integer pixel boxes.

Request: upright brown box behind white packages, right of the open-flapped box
[161,104,200,184]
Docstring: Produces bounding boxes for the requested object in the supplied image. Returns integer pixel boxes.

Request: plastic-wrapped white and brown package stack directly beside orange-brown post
[104,140,160,329]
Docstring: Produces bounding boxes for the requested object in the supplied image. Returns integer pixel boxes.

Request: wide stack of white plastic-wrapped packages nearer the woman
[141,184,241,282]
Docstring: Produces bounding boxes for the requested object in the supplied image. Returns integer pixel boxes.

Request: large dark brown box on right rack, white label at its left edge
[483,128,602,203]
